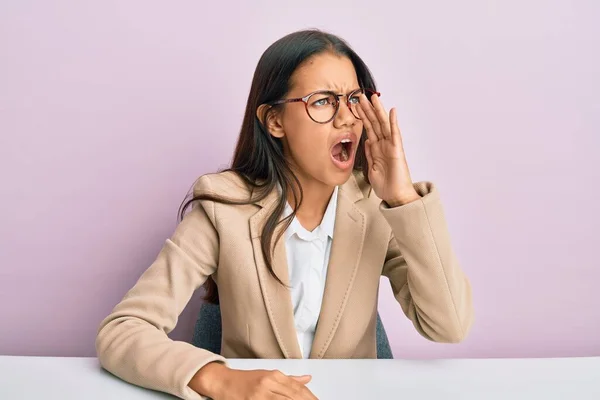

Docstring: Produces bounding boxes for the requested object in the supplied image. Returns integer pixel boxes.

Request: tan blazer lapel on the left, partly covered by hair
[250,189,302,358]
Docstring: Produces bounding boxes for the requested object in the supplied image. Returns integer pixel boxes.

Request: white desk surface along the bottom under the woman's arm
[0,356,600,400]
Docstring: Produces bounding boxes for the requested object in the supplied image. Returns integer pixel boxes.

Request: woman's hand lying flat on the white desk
[189,362,317,400]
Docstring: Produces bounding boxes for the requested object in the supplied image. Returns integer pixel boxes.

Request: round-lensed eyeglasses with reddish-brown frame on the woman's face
[267,88,381,124]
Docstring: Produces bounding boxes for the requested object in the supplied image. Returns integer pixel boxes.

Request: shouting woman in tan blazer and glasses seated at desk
[96,30,473,400]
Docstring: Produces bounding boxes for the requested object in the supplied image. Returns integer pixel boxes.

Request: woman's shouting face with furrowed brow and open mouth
[268,53,363,186]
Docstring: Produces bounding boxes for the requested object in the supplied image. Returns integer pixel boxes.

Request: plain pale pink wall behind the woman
[0,0,600,358]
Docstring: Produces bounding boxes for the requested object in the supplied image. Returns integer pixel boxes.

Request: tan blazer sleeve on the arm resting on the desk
[96,176,226,400]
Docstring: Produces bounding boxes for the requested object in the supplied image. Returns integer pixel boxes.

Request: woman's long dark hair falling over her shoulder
[179,29,376,304]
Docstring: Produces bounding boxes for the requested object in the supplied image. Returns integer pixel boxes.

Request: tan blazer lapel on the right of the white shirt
[310,175,366,358]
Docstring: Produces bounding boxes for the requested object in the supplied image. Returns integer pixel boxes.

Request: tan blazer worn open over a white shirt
[96,172,473,399]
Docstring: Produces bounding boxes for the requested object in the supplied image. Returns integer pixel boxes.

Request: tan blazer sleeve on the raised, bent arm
[379,182,474,343]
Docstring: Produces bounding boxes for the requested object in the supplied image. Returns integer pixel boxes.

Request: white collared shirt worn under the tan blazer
[284,186,338,358]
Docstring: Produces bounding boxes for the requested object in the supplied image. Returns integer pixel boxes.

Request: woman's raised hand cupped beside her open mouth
[358,94,421,207]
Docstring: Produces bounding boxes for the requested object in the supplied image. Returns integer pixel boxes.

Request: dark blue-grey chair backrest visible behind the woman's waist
[192,303,394,359]
